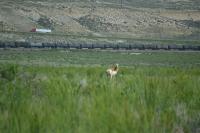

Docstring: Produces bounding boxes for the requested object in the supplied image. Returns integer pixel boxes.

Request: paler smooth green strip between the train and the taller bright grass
[0,49,200,68]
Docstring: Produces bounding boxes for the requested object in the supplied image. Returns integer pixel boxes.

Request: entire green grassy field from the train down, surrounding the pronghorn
[0,50,200,133]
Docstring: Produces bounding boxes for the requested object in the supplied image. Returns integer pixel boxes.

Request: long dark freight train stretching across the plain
[0,41,200,51]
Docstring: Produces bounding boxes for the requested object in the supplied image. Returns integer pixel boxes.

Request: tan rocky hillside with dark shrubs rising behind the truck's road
[0,0,200,40]
